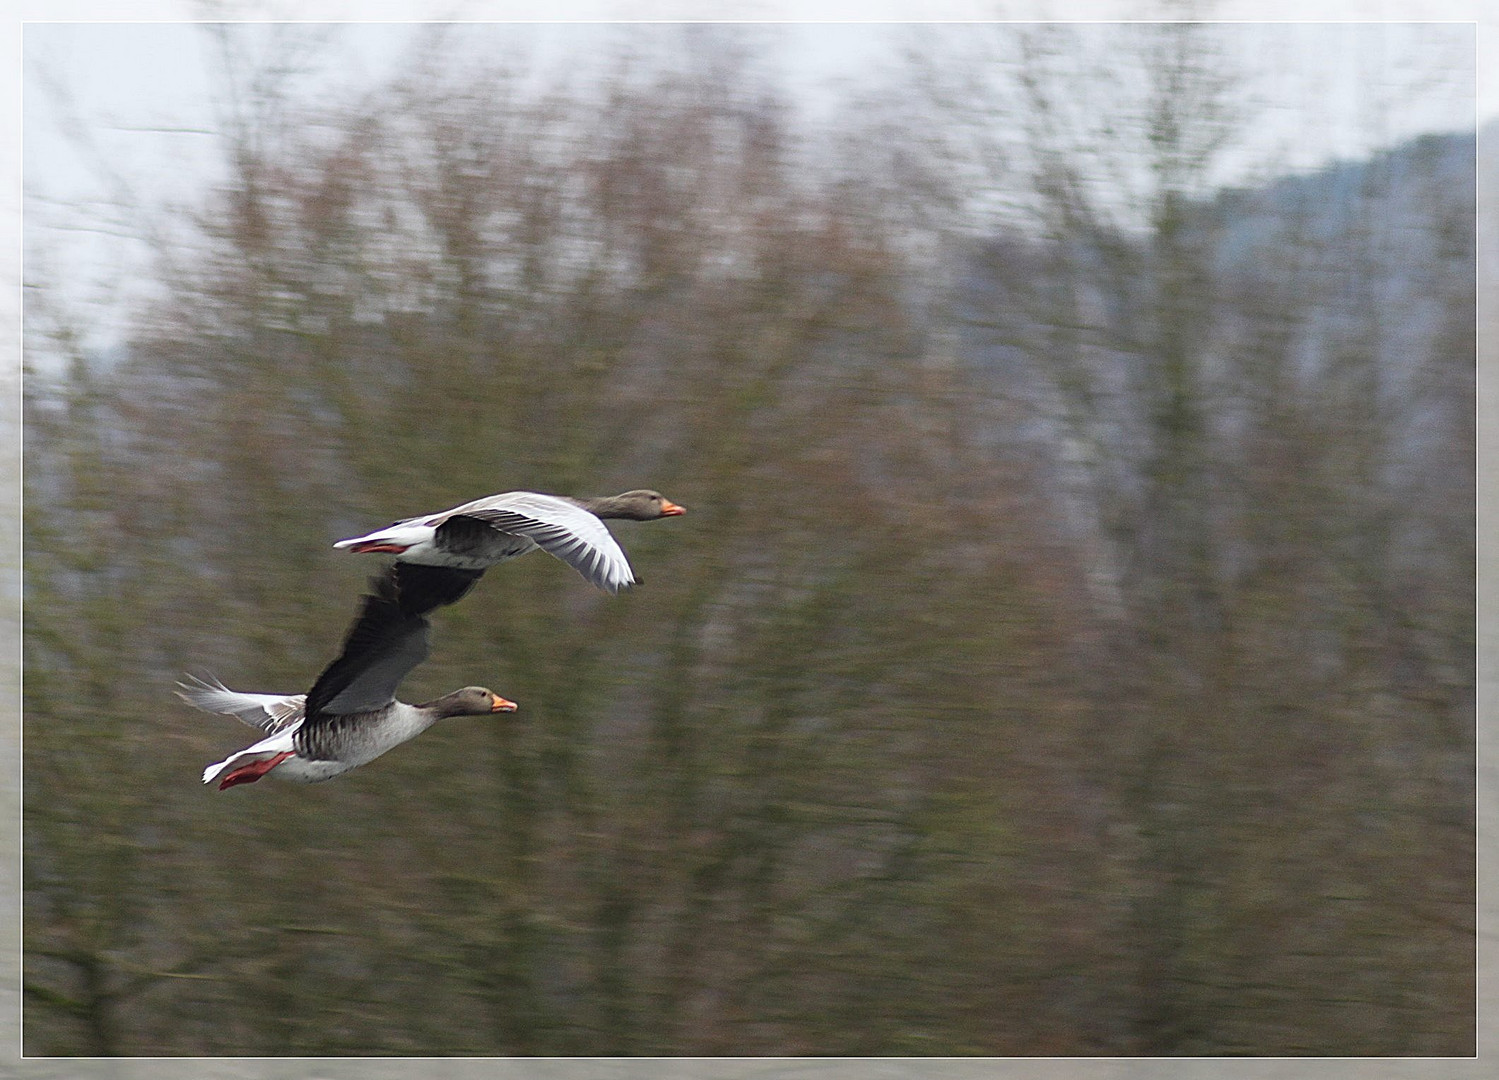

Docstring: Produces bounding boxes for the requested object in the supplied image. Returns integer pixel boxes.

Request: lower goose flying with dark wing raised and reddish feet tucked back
[178,572,516,791]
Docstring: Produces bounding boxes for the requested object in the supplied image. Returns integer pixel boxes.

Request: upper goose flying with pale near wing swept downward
[333,491,687,611]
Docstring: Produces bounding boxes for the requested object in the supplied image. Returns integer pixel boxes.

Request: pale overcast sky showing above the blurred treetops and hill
[5,0,1499,367]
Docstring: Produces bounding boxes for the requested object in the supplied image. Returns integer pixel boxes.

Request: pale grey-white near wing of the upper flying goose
[437,492,636,593]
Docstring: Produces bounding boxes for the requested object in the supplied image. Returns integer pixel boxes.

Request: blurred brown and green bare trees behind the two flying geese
[24,24,1475,1055]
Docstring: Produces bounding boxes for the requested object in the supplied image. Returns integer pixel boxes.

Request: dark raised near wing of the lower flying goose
[303,570,430,731]
